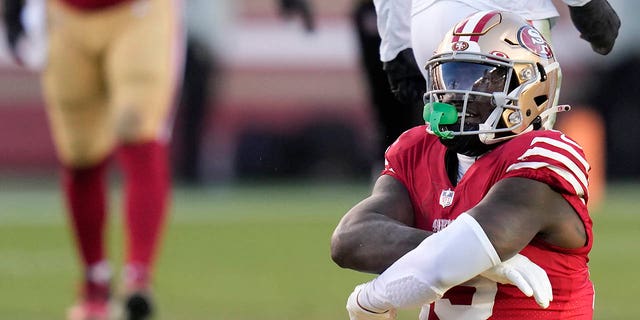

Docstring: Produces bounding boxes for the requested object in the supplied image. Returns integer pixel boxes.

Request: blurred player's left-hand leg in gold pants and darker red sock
[42,2,115,319]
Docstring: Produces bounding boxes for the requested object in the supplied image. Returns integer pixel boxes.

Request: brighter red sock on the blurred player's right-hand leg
[117,142,170,276]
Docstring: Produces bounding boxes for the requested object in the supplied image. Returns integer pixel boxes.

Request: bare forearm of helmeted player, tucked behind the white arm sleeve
[331,213,431,274]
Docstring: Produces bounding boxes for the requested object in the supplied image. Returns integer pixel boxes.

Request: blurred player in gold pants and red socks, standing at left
[4,0,184,320]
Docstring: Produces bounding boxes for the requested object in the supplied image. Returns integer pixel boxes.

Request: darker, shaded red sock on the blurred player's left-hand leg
[62,161,107,269]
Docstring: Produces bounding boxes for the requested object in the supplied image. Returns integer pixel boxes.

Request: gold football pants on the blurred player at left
[42,0,184,167]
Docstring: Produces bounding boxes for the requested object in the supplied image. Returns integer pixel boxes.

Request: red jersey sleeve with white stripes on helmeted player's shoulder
[503,130,590,203]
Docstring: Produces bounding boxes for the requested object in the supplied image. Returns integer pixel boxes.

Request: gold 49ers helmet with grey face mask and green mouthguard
[424,11,561,154]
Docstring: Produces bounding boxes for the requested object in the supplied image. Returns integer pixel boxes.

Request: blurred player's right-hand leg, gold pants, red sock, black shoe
[106,0,185,319]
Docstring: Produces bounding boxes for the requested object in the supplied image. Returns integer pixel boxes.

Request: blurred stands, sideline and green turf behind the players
[0,0,640,319]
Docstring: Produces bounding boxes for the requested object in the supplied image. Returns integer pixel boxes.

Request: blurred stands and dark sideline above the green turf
[0,0,640,183]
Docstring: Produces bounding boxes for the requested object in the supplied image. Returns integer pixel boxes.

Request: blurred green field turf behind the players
[0,182,640,320]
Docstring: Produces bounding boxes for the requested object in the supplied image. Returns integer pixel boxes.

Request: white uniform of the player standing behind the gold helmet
[374,0,591,64]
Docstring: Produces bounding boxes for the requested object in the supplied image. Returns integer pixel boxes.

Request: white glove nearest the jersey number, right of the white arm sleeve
[480,254,553,309]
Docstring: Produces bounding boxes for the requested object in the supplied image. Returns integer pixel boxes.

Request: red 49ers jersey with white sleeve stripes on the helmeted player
[383,126,594,320]
